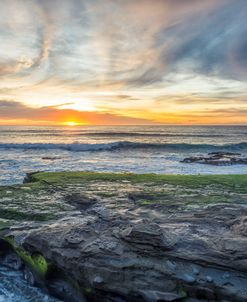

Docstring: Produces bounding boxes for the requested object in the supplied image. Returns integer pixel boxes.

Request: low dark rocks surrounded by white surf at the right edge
[181,152,247,166]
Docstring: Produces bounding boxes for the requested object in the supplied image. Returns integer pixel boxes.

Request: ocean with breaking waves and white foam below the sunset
[0,126,247,184]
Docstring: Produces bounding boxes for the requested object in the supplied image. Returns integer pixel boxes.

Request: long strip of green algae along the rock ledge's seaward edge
[27,172,247,193]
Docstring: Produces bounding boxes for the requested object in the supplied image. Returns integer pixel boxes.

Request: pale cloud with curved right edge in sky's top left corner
[0,0,54,76]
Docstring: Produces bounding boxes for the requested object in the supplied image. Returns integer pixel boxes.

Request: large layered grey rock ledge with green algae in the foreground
[0,172,247,302]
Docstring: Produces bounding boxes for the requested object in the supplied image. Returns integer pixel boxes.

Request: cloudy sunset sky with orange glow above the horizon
[0,0,247,125]
